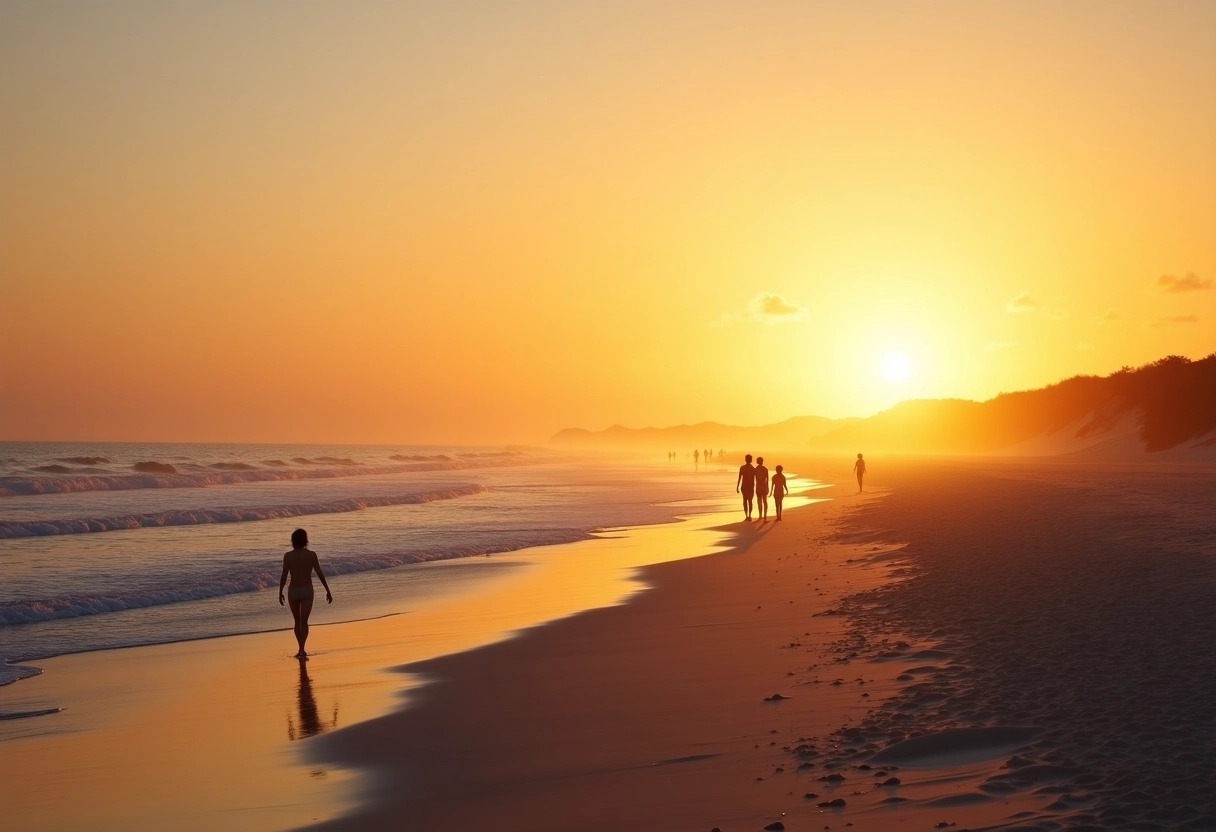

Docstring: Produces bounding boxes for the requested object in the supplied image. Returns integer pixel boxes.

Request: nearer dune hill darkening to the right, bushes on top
[810,354,1216,459]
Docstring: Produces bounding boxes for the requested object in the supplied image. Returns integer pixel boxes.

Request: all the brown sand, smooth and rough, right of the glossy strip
[306,462,1216,832]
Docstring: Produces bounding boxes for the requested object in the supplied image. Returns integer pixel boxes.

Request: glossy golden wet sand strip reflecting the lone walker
[0,484,758,831]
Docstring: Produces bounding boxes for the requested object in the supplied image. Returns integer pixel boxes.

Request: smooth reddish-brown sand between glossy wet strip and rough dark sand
[310,474,896,832]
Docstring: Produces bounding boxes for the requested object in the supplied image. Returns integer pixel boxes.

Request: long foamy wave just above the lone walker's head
[0,484,486,539]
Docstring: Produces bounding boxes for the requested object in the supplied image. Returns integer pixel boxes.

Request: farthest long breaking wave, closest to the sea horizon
[0,457,529,497]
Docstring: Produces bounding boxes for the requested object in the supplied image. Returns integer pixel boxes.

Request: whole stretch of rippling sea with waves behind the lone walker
[0,443,734,684]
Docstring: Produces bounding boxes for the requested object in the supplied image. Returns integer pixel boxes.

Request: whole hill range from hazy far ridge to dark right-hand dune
[550,353,1216,462]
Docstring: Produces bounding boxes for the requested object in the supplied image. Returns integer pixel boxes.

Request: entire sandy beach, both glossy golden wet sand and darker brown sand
[4,460,1216,832]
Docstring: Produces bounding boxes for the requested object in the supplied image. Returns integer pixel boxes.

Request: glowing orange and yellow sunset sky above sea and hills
[0,0,1216,443]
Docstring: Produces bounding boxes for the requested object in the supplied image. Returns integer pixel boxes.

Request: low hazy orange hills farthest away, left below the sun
[550,416,857,452]
